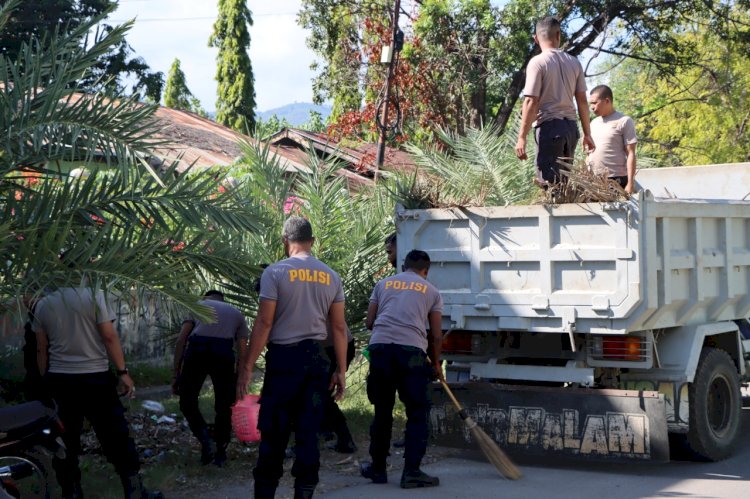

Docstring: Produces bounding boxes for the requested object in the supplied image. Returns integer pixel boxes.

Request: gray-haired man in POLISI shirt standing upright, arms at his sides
[237,217,347,499]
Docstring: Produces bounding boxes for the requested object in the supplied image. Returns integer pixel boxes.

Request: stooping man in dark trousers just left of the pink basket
[172,290,248,466]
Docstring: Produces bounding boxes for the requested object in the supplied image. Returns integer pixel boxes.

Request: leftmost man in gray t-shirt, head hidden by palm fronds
[32,287,160,498]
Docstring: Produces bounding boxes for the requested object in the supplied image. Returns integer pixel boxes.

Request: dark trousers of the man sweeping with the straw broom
[367,344,432,471]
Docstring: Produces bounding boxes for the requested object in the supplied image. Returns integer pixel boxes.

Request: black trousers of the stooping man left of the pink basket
[180,336,237,446]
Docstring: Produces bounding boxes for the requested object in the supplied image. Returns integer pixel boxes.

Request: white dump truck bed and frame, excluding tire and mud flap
[396,164,750,460]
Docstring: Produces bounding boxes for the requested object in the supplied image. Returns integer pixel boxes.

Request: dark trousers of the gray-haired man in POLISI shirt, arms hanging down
[253,340,330,491]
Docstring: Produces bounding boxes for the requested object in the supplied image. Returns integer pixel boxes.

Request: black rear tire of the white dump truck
[686,348,742,461]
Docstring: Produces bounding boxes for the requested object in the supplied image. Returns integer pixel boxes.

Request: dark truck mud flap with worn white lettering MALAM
[430,382,669,462]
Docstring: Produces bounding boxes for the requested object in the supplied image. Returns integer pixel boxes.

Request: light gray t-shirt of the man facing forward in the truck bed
[588,111,638,177]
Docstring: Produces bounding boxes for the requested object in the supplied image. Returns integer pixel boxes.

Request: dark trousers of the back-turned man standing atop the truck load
[534,120,578,184]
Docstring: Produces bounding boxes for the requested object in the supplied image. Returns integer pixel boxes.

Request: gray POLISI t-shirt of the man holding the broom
[370,271,443,352]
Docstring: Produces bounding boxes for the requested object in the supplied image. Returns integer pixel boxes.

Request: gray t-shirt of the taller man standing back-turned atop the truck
[523,49,586,125]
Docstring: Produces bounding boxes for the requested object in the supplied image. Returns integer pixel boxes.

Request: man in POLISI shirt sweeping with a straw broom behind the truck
[360,250,443,489]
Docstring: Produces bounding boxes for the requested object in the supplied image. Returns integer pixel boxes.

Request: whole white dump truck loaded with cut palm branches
[395,163,750,461]
